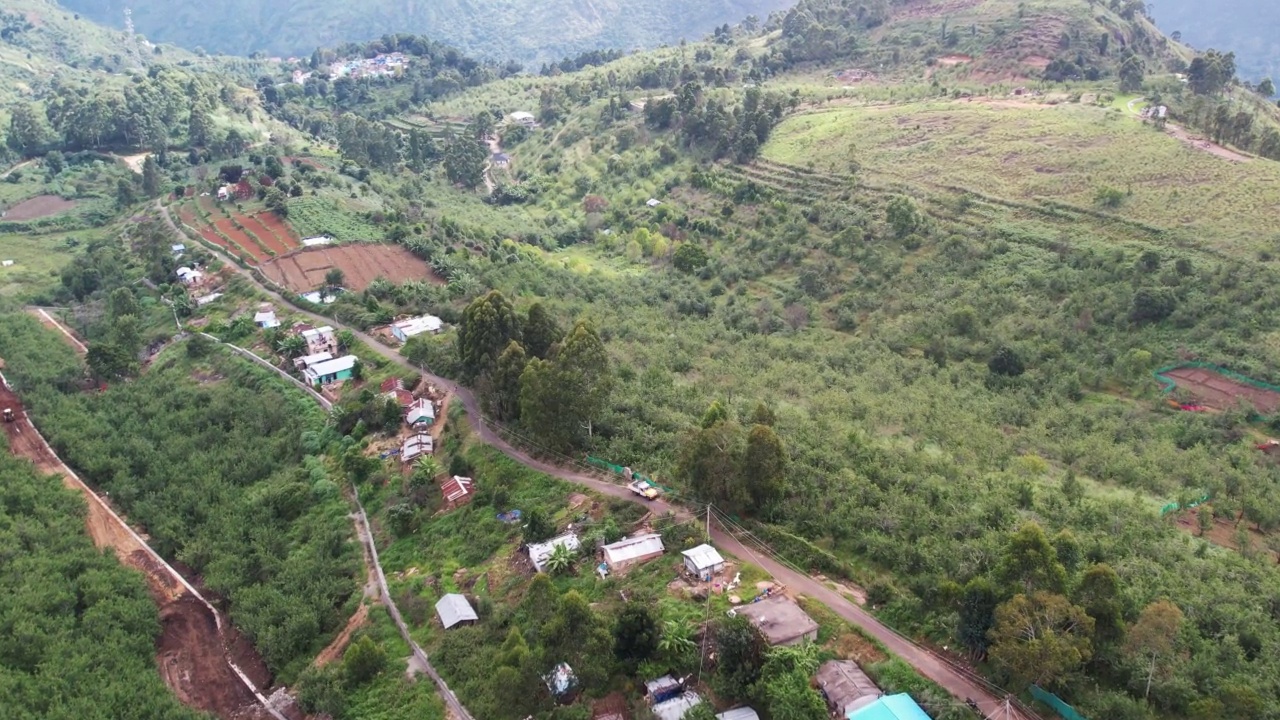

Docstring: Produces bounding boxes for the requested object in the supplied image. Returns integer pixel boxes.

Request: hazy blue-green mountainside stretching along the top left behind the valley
[63,0,790,63]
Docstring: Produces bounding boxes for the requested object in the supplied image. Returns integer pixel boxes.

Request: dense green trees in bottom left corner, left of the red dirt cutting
[0,450,204,720]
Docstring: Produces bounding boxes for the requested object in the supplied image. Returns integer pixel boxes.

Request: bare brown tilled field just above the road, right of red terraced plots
[261,243,444,292]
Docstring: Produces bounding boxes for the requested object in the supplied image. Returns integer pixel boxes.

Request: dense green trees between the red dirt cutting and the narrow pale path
[0,315,358,682]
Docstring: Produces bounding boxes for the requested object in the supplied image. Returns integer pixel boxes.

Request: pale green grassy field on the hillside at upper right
[763,101,1280,251]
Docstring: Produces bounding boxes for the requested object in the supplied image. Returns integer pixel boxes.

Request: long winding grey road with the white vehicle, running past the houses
[156,202,1034,720]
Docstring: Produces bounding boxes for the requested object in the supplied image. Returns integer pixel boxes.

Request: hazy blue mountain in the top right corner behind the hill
[1155,0,1280,81]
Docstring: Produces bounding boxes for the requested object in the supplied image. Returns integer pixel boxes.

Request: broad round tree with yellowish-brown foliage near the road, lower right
[988,592,1093,685]
